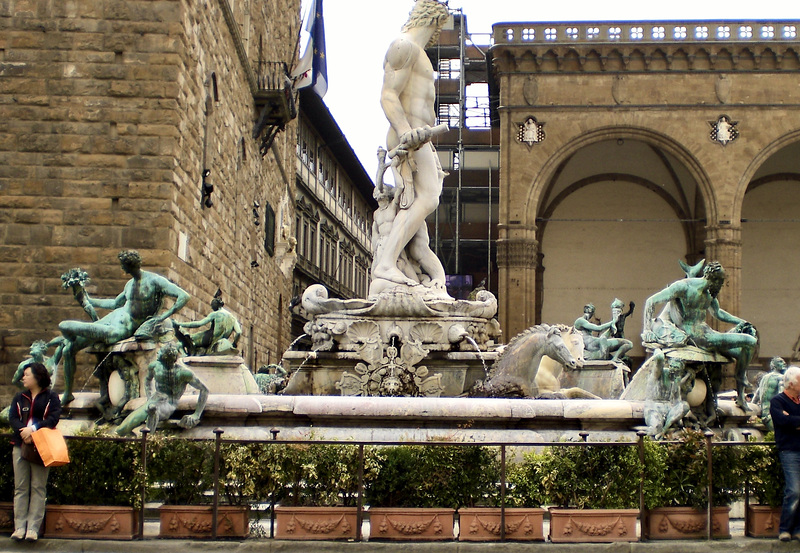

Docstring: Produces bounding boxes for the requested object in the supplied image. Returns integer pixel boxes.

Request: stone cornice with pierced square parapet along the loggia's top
[492,22,800,73]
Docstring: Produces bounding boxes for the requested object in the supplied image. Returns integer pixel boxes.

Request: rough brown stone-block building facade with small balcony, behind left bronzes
[0,0,300,392]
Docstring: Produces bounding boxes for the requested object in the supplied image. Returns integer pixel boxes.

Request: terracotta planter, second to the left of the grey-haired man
[645,507,731,540]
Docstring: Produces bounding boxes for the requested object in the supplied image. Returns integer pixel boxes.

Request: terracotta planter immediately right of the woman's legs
[44,505,139,540]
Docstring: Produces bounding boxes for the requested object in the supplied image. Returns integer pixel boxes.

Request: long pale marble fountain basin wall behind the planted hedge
[59,393,760,443]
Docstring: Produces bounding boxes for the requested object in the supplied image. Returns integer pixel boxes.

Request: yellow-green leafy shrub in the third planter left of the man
[540,444,641,509]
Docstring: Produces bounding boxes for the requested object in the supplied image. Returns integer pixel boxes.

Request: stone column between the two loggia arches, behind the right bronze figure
[706,222,747,320]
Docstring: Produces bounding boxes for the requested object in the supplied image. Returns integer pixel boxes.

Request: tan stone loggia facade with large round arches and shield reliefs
[491,21,800,361]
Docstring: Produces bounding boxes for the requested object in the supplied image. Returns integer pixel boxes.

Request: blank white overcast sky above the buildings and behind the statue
[303,0,797,176]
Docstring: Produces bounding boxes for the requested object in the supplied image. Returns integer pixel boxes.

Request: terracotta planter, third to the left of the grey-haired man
[550,509,639,543]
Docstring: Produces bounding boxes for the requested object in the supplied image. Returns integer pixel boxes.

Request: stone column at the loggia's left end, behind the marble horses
[497,225,539,336]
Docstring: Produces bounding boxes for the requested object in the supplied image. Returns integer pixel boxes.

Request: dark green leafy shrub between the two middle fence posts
[367,445,500,509]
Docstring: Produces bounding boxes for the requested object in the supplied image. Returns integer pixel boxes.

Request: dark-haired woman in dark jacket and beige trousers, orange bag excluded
[8,363,61,541]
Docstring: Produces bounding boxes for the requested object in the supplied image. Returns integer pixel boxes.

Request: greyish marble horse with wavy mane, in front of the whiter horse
[469,324,579,397]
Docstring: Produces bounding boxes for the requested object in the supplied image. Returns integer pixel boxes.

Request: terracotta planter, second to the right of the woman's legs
[158,505,250,538]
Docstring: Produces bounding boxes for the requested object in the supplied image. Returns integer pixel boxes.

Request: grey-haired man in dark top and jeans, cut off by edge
[769,367,800,541]
